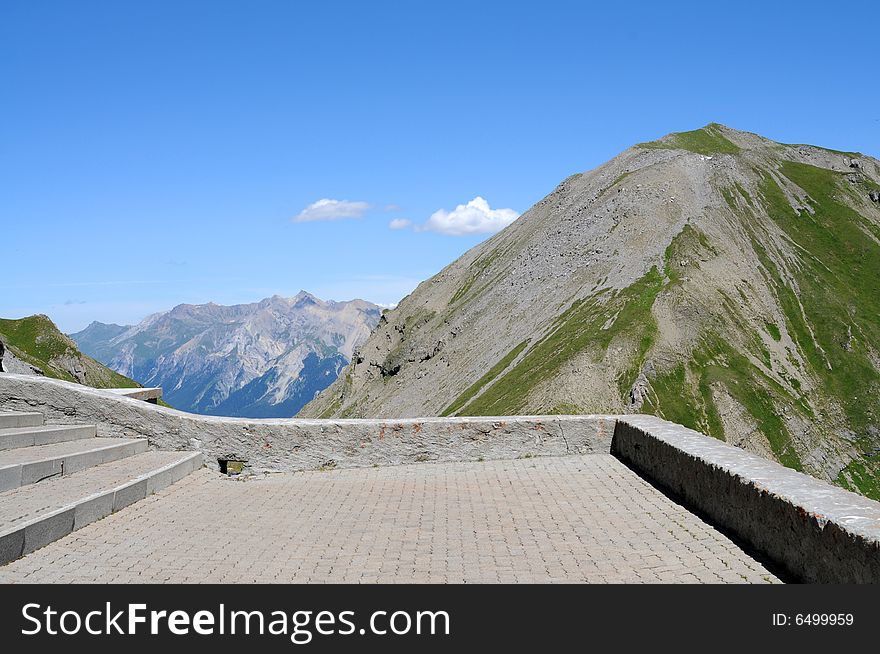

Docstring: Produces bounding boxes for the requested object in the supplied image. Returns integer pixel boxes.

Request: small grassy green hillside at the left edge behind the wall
[0,315,140,388]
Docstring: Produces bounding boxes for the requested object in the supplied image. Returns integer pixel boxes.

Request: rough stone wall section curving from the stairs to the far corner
[0,373,614,472]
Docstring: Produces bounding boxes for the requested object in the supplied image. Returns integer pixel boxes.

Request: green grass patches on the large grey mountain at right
[442,155,880,499]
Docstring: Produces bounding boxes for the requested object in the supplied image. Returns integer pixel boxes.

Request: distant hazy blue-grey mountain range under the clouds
[71,292,380,418]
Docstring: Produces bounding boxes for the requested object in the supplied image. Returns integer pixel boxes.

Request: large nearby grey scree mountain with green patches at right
[301,124,880,497]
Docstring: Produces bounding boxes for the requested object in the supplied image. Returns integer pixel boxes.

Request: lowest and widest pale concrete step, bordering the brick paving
[0,452,202,565]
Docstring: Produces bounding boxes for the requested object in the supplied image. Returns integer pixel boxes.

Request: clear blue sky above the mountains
[0,0,880,331]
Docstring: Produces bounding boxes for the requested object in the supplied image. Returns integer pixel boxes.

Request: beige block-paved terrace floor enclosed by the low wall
[0,454,779,583]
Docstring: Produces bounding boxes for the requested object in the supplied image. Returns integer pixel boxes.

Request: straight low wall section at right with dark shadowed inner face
[611,416,880,583]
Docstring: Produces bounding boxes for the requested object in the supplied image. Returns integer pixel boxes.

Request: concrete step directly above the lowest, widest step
[0,438,149,492]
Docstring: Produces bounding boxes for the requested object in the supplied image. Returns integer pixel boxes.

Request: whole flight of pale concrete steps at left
[0,413,202,565]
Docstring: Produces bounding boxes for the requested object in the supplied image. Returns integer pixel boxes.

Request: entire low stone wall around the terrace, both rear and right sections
[0,373,880,583]
